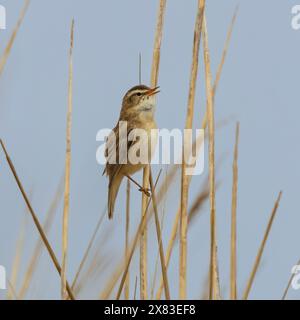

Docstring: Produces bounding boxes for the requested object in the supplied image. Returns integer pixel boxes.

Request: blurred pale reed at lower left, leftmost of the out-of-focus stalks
[6,215,27,300]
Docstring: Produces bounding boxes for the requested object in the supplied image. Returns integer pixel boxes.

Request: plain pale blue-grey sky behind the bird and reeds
[0,0,300,299]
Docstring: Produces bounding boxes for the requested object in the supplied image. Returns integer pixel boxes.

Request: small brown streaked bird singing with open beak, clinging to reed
[103,85,159,219]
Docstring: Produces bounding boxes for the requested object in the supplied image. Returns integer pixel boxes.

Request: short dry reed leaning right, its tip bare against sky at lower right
[243,191,282,300]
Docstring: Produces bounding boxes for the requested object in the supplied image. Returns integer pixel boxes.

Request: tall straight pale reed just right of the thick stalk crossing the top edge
[203,17,220,299]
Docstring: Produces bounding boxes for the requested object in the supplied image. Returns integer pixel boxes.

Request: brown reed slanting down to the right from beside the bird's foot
[150,168,170,300]
